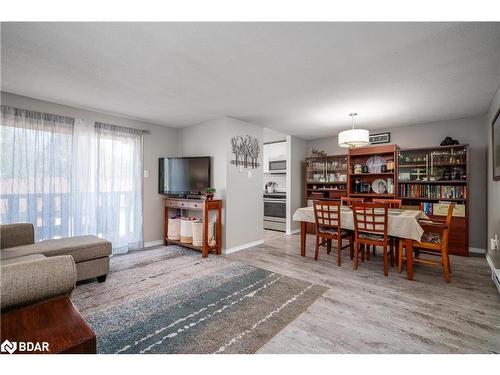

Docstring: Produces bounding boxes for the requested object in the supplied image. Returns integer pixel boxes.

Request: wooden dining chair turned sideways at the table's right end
[398,203,455,283]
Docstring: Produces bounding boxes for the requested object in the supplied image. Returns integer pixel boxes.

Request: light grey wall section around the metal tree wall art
[179,117,264,252]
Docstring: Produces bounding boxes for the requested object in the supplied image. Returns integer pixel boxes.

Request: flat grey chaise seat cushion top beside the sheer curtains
[1,236,111,263]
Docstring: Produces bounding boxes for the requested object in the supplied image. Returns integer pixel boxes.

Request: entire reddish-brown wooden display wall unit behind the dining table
[304,144,470,256]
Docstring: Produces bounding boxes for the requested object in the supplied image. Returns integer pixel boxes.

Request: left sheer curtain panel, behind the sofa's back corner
[0,106,73,240]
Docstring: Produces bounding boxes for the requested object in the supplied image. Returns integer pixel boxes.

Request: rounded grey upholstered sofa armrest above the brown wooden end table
[0,255,76,310]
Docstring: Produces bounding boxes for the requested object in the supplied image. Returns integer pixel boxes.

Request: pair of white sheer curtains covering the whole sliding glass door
[0,106,143,254]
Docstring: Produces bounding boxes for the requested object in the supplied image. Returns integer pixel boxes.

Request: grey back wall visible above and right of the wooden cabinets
[307,116,487,251]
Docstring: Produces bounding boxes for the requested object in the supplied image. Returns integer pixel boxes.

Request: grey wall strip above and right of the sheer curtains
[1,92,178,242]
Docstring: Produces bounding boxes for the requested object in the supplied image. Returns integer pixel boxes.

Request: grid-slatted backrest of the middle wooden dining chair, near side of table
[352,202,388,239]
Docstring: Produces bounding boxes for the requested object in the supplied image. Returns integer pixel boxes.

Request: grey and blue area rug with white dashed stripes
[72,246,326,353]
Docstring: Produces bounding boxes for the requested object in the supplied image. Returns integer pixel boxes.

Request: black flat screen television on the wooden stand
[158,156,211,195]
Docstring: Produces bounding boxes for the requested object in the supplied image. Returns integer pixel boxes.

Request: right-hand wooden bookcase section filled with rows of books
[397,145,469,255]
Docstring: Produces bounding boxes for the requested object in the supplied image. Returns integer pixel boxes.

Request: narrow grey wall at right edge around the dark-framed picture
[485,88,500,254]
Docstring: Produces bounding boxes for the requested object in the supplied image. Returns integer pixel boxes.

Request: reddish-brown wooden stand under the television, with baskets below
[163,197,222,258]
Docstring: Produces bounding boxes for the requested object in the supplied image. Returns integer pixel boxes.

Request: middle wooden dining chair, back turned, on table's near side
[352,202,394,276]
